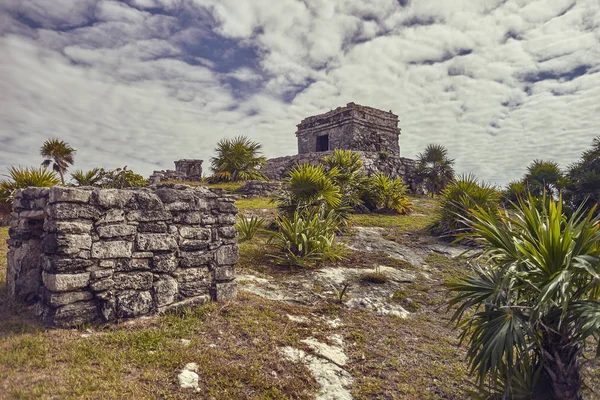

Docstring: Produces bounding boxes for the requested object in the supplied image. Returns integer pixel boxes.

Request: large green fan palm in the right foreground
[449,195,600,400]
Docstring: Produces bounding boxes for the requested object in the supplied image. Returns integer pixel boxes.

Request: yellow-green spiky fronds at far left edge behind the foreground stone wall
[0,167,60,203]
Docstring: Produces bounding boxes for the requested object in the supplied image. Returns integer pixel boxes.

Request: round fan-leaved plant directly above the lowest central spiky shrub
[277,164,344,218]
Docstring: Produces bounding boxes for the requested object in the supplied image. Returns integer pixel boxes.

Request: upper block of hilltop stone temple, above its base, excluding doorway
[296,103,400,155]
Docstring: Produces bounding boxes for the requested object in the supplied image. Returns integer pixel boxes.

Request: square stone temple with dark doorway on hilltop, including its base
[263,103,418,191]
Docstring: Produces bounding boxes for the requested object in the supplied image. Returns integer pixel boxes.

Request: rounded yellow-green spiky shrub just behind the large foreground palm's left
[430,174,500,235]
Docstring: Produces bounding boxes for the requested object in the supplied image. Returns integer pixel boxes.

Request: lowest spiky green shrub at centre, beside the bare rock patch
[269,210,344,266]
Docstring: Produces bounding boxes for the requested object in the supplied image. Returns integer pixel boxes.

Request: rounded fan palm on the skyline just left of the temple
[210,136,266,181]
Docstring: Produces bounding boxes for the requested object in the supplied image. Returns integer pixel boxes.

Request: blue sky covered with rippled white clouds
[0,0,600,184]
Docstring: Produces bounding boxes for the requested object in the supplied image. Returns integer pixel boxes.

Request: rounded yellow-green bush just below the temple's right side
[361,173,413,214]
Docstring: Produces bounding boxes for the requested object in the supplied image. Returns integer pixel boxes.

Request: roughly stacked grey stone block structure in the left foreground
[7,184,238,327]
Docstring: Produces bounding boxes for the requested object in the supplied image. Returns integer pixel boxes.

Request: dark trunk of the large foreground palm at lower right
[542,330,583,400]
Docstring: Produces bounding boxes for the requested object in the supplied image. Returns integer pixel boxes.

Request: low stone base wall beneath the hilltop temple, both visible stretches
[262,151,422,192]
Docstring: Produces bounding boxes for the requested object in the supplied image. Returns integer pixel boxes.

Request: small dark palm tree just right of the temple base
[417,144,454,197]
